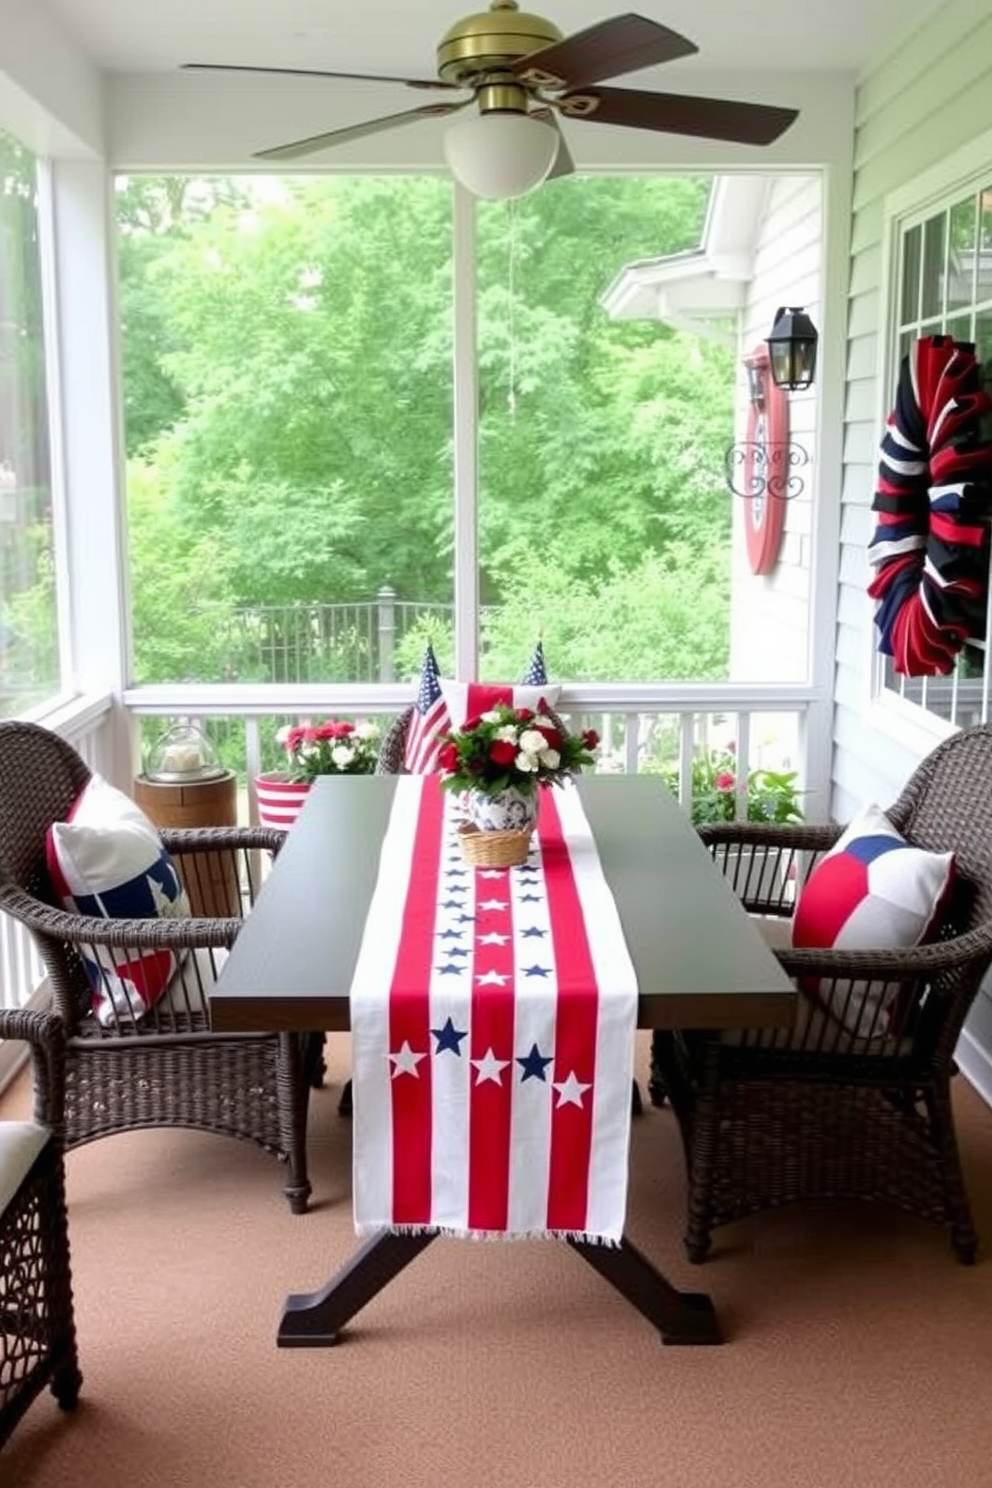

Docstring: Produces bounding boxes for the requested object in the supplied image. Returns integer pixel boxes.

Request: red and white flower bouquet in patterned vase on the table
[437,699,599,832]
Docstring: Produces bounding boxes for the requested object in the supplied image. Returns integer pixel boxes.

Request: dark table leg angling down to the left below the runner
[275,1234,436,1348]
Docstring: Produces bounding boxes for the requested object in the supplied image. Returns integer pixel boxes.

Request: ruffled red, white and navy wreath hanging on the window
[869,336,992,677]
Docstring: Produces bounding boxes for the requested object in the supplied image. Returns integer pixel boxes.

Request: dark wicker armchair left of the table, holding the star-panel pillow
[0,723,320,1214]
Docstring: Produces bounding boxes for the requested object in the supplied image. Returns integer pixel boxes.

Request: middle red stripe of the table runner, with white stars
[468,869,516,1231]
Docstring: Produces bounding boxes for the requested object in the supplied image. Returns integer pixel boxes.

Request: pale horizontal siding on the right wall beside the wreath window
[833,0,992,1094]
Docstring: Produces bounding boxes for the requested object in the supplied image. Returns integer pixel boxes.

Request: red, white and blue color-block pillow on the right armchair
[793,805,955,1037]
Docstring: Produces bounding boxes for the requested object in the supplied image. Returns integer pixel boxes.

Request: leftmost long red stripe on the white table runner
[390,775,445,1225]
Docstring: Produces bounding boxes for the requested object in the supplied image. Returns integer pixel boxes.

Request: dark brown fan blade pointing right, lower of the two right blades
[556,88,799,144]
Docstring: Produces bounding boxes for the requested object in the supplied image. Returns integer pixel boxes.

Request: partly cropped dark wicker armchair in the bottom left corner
[0,1010,82,1446]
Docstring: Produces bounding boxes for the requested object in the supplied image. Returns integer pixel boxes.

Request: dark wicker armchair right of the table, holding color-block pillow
[650,726,992,1263]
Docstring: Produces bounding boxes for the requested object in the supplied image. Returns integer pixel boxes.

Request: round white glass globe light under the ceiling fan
[445,110,559,201]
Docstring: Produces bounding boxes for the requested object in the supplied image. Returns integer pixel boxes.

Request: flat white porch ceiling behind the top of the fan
[36,0,938,79]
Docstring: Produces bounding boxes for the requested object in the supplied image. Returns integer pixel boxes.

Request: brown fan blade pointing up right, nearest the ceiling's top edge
[512,15,699,89]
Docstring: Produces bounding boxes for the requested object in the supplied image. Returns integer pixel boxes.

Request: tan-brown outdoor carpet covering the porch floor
[0,1037,992,1488]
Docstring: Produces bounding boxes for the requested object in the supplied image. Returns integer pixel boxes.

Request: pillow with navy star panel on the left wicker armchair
[46,775,190,1025]
